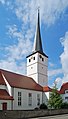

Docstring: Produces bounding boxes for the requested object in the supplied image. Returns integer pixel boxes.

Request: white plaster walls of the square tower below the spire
[27,53,48,86]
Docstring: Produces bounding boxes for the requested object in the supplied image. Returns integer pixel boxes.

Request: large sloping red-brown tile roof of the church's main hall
[0,69,43,91]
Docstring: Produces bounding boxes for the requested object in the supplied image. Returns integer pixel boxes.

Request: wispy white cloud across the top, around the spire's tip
[13,0,68,25]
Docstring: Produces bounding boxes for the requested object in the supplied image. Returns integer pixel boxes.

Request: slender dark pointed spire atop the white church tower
[33,8,43,53]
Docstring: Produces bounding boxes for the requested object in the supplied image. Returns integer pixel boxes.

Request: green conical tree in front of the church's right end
[48,85,62,109]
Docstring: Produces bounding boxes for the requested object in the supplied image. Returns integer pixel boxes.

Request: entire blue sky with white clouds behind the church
[0,0,68,88]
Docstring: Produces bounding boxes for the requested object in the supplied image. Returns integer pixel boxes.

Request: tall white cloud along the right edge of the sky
[60,32,68,83]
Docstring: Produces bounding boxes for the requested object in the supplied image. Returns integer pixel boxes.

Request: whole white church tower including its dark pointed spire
[27,10,48,86]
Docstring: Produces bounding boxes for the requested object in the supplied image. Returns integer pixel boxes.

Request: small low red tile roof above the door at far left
[0,89,13,100]
